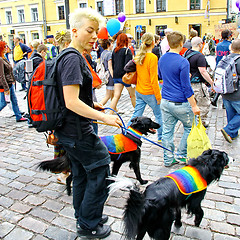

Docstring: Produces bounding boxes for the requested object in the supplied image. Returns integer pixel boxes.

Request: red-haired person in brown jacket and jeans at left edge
[0,41,28,122]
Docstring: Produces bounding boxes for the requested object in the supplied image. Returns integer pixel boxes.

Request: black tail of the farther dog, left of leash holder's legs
[37,154,70,173]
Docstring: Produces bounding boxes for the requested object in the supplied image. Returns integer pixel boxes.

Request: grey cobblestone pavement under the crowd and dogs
[0,83,240,240]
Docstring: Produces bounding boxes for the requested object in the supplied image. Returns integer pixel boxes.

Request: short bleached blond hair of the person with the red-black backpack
[69,8,105,30]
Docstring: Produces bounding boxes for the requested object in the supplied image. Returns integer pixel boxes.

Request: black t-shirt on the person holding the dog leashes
[57,50,93,138]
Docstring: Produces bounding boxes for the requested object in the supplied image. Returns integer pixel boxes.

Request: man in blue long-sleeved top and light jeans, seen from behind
[158,32,200,167]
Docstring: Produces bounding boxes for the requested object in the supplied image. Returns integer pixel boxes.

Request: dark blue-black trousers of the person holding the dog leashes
[55,130,110,229]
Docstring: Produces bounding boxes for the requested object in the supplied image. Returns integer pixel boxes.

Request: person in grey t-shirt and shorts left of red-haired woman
[100,39,114,105]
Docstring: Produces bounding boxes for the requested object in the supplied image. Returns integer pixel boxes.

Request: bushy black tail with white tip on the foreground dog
[109,177,145,240]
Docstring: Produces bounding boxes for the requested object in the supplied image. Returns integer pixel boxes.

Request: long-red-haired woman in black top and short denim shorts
[110,33,136,114]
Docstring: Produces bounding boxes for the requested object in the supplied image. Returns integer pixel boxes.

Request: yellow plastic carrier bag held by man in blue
[187,116,212,158]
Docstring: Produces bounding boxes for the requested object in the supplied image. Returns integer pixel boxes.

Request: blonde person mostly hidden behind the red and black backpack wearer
[54,30,72,184]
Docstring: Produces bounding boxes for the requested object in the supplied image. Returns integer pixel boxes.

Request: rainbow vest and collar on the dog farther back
[100,127,142,154]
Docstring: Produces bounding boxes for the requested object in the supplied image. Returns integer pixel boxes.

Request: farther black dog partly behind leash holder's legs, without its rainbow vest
[38,117,160,195]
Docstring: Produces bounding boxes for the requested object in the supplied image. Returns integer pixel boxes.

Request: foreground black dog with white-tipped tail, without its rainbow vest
[110,150,232,240]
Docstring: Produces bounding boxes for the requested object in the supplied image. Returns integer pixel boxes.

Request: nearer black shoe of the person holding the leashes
[77,225,111,239]
